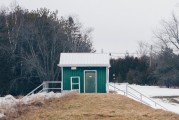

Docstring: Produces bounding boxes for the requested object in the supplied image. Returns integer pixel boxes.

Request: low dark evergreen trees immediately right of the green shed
[110,55,152,84]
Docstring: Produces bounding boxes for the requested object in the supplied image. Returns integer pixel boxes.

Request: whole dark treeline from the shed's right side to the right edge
[110,48,179,87]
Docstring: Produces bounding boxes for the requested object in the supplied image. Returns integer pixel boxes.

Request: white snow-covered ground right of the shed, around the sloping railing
[109,83,179,114]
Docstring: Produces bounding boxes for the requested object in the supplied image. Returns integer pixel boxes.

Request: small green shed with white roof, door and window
[58,53,110,93]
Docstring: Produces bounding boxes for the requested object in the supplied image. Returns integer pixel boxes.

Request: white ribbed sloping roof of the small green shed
[58,53,110,67]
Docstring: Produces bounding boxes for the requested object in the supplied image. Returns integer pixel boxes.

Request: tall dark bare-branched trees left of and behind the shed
[0,6,94,95]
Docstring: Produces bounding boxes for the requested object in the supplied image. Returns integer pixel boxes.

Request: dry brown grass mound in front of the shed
[14,94,179,120]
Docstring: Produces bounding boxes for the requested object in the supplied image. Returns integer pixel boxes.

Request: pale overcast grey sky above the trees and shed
[0,0,179,53]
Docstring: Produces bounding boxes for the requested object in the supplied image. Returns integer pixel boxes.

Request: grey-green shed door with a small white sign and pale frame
[85,71,96,93]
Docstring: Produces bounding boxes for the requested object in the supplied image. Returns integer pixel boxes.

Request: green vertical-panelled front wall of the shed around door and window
[63,67,106,93]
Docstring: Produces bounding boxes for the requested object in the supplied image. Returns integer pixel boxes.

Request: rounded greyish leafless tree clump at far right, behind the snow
[153,48,179,87]
